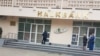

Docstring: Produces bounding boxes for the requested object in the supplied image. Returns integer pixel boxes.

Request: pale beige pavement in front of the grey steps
[0,47,72,56]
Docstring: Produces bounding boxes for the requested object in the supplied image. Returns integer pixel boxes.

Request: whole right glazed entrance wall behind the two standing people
[72,21,100,48]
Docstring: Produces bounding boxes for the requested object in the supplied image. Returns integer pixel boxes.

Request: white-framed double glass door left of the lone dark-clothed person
[30,24,44,43]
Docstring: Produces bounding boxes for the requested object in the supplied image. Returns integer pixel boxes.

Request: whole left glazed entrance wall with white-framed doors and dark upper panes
[18,18,51,44]
